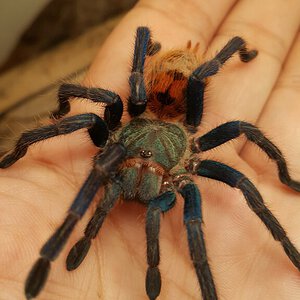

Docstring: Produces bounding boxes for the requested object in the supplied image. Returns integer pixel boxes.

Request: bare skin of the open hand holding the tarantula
[0,0,300,300]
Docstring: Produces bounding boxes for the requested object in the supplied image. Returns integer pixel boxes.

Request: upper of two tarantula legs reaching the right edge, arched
[192,121,300,192]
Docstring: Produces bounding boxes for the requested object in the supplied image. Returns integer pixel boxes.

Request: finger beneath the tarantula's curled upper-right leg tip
[199,0,300,136]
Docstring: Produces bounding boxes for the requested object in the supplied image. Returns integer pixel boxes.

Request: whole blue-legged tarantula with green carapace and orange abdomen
[0,27,300,300]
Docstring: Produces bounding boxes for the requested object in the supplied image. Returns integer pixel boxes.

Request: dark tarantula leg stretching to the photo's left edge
[0,114,109,169]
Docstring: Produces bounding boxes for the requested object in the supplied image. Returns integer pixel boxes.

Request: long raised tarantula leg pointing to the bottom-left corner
[25,144,126,299]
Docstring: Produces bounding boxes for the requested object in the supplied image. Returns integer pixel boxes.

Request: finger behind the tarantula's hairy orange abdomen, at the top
[88,0,236,90]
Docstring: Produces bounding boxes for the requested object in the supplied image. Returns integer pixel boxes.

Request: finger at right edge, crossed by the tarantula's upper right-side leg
[241,33,300,180]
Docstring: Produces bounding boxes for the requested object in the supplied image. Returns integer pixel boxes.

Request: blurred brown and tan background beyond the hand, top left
[0,0,137,155]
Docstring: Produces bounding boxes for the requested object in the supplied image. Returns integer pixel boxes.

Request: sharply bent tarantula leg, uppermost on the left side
[52,83,123,129]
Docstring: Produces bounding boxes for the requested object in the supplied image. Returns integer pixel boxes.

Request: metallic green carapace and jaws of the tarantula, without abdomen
[119,118,187,203]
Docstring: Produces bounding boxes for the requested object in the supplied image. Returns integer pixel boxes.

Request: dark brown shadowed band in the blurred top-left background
[0,0,137,73]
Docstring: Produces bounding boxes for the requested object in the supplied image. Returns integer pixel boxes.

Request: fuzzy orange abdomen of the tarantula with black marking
[145,43,200,118]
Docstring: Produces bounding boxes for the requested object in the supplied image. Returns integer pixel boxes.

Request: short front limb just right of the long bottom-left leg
[66,182,121,271]
